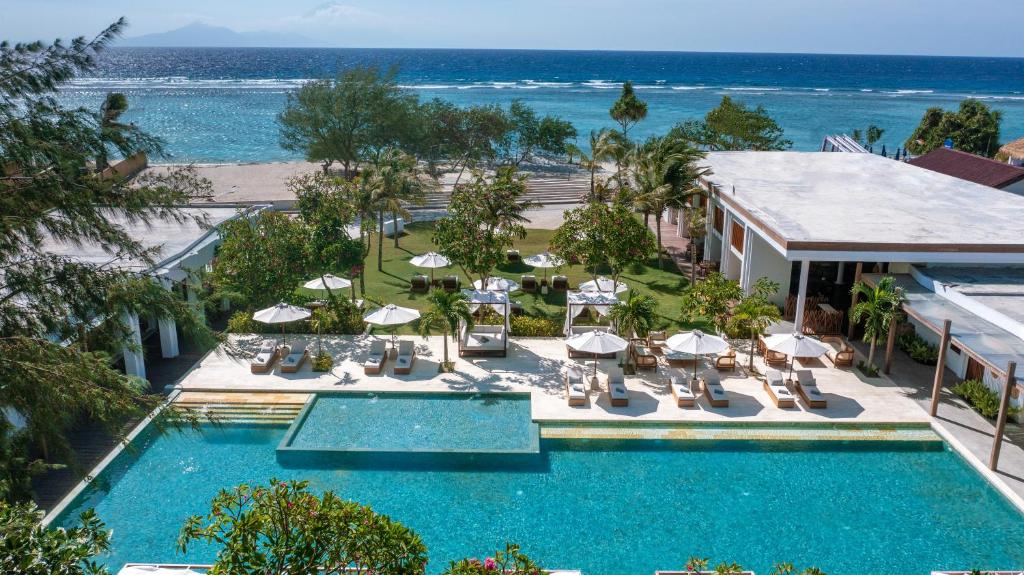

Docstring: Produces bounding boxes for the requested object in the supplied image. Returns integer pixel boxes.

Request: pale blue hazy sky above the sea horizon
[6,0,1024,56]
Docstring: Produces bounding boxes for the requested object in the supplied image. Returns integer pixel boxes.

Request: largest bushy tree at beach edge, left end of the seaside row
[278,67,419,178]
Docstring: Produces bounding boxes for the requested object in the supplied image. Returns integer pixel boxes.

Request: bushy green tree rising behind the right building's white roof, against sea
[670,96,793,151]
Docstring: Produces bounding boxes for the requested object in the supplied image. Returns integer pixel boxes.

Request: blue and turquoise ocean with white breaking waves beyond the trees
[63,48,1024,163]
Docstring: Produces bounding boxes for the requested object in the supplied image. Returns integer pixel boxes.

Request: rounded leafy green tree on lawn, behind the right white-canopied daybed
[551,203,654,281]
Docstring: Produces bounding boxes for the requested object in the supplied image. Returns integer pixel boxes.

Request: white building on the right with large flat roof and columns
[701,151,1024,403]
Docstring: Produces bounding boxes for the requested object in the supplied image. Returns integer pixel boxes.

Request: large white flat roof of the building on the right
[705,151,1024,254]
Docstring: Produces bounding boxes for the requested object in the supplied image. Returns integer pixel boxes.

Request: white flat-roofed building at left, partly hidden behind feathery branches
[36,205,261,378]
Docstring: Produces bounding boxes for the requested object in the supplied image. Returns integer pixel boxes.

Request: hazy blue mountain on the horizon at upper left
[117,21,322,48]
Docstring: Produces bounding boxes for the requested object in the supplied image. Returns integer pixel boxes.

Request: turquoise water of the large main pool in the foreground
[56,426,1024,575]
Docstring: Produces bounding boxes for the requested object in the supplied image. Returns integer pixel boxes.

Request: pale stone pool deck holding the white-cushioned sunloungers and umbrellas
[180,336,930,424]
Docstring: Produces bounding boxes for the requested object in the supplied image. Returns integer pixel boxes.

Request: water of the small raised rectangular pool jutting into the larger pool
[282,393,538,452]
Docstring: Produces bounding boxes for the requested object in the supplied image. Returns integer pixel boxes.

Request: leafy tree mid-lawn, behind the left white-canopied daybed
[432,168,536,281]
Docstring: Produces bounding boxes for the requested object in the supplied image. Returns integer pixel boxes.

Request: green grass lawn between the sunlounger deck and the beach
[352,222,704,333]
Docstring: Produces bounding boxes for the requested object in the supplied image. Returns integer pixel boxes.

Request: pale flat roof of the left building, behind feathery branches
[36,206,240,271]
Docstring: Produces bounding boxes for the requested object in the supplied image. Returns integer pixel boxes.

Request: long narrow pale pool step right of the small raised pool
[541,424,942,443]
